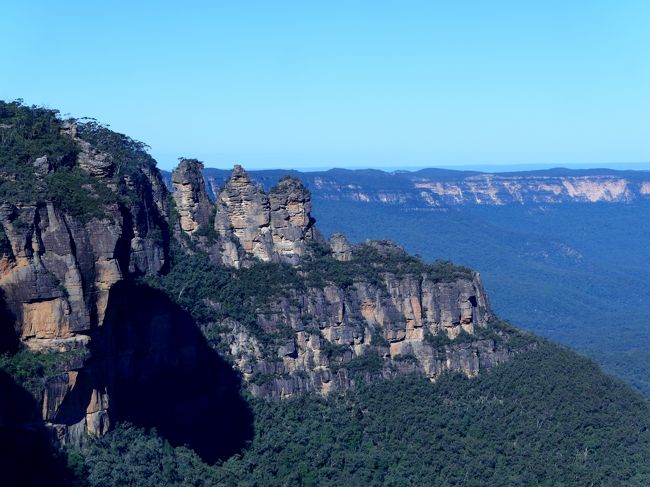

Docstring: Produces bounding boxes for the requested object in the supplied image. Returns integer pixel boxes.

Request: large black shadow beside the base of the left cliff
[96,282,253,462]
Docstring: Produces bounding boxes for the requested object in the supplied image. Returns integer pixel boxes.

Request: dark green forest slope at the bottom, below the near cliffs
[76,342,650,486]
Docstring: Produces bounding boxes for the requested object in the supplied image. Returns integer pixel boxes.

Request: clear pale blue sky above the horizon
[0,0,650,172]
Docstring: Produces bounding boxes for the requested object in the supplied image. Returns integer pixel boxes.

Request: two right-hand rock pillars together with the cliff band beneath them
[168,166,513,398]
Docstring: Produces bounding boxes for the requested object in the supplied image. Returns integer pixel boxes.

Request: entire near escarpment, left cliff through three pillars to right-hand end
[0,99,530,454]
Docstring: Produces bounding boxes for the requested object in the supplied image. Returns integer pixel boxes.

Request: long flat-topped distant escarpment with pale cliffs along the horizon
[163,168,650,209]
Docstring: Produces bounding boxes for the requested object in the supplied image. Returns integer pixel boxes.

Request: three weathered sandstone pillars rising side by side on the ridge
[172,164,316,268]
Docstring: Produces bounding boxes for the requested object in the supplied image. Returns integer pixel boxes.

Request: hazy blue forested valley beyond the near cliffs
[189,169,650,396]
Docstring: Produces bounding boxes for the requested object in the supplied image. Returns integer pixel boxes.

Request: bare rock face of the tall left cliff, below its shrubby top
[0,131,167,441]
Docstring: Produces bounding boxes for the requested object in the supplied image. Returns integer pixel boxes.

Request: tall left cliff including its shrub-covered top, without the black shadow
[0,106,175,442]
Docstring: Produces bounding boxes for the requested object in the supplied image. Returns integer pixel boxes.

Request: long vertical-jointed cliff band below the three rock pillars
[215,266,504,398]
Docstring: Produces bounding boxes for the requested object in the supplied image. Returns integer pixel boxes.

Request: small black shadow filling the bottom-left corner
[0,370,73,486]
